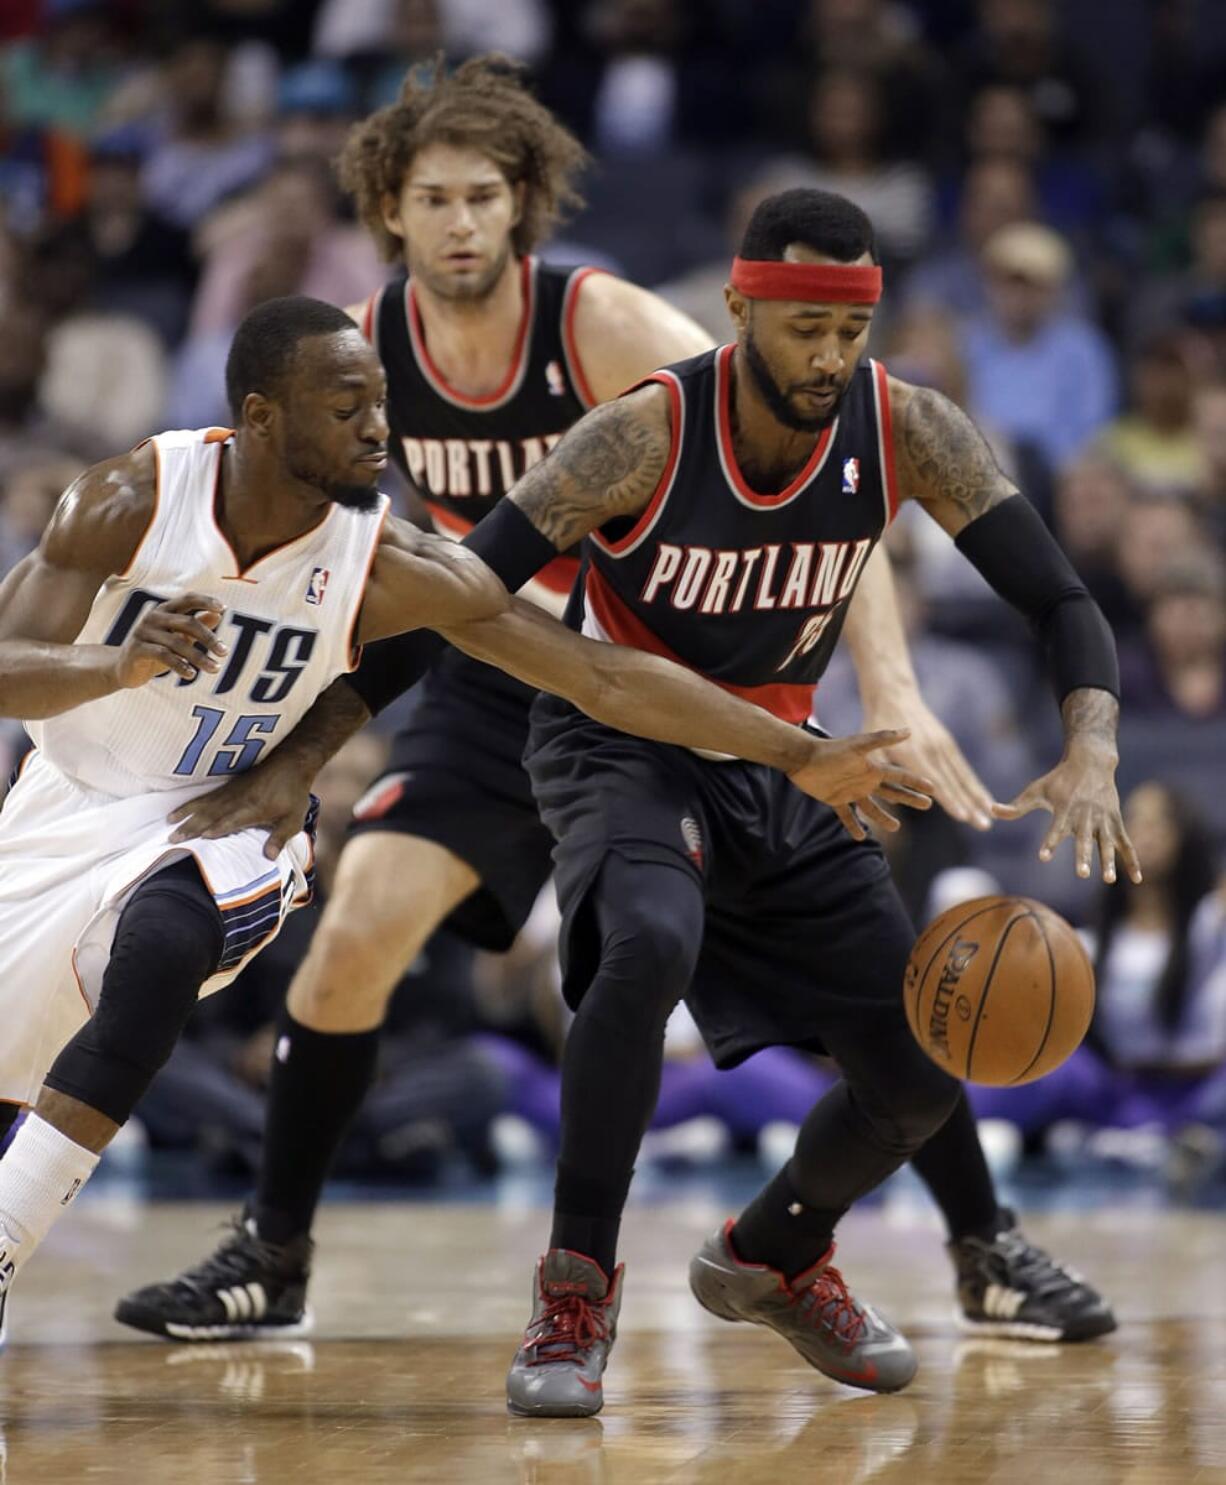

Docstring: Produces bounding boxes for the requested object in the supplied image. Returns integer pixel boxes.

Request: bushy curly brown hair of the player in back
[338,52,588,263]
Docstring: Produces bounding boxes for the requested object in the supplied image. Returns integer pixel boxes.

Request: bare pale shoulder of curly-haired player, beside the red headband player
[573,273,714,402]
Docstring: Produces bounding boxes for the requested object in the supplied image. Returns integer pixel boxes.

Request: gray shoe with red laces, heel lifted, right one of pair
[690,1219,916,1391]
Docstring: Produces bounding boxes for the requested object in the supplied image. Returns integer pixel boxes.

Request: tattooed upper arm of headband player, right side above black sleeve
[902,388,1017,526]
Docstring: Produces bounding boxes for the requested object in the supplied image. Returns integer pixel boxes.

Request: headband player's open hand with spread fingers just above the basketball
[991,748,1141,882]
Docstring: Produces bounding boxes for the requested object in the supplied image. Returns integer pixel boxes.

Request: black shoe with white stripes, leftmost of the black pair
[114,1213,313,1341]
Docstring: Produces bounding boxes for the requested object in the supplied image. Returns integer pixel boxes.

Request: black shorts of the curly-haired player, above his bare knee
[350,650,554,950]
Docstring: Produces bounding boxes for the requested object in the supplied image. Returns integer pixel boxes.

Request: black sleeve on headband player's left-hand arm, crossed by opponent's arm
[344,500,558,716]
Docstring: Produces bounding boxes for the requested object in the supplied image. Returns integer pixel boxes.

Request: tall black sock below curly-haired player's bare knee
[251,1007,381,1243]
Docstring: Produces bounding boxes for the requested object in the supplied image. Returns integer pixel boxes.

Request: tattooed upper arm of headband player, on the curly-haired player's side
[511,395,669,551]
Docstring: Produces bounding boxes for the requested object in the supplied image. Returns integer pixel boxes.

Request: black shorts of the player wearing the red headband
[525,695,914,1068]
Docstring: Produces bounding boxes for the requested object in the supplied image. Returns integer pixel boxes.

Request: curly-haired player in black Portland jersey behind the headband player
[119,72,1110,1366]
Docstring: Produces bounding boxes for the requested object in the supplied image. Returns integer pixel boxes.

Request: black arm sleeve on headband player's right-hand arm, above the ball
[954,495,1119,701]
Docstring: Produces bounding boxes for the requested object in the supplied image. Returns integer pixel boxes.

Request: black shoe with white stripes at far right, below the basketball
[948,1210,1116,1342]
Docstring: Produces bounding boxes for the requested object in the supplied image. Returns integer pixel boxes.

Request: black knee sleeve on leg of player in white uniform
[46,861,226,1124]
